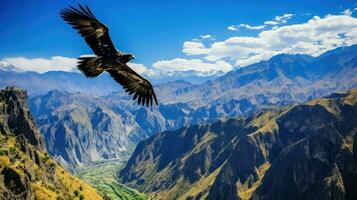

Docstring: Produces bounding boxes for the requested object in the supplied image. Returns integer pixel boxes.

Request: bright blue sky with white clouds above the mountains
[0,0,357,73]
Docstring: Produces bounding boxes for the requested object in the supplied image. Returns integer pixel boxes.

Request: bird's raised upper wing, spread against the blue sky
[60,5,117,56]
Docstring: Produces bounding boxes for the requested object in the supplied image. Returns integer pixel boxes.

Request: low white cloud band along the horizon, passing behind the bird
[0,55,233,77]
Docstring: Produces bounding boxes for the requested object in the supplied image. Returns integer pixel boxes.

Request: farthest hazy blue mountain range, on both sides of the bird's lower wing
[0,62,223,96]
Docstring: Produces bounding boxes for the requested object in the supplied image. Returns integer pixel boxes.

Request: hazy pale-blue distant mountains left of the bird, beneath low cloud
[0,69,121,96]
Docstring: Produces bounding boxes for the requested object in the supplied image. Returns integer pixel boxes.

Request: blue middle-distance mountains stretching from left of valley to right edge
[30,45,357,170]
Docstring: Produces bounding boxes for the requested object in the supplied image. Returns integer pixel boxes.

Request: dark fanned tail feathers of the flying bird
[77,56,104,78]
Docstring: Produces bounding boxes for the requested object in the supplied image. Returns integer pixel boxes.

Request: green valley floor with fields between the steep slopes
[78,161,147,200]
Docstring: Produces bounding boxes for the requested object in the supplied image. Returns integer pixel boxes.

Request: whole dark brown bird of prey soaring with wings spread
[60,5,158,106]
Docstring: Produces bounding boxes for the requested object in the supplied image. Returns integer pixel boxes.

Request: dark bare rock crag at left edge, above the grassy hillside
[0,87,44,150]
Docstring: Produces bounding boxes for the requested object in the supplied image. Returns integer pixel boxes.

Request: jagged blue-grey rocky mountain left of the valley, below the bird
[29,91,145,171]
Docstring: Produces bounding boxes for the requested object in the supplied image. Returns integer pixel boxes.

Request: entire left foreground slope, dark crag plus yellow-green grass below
[0,87,102,200]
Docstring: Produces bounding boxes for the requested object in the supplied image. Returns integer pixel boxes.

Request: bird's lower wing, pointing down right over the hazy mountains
[106,65,158,106]
